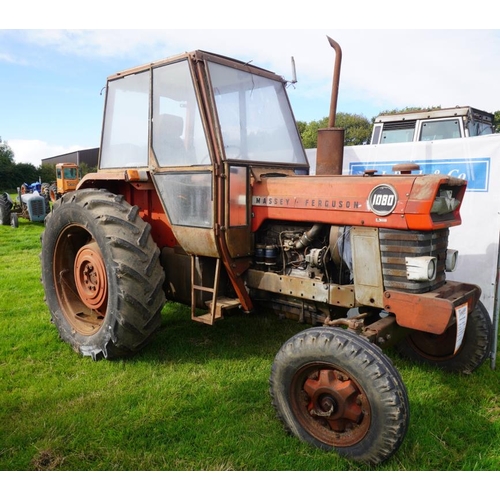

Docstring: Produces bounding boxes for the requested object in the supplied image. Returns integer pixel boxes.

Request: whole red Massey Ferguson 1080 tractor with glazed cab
[41,39,493,463]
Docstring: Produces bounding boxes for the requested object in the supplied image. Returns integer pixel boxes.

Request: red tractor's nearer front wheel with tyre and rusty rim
[270,327,409,464]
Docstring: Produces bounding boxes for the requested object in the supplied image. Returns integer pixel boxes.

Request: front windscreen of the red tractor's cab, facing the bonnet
[209,62,307,164]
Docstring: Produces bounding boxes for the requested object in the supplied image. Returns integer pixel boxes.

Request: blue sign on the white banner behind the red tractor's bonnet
[349,158,491,192]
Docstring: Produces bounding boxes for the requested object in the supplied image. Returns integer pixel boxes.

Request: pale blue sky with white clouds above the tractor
[0,4,500,166]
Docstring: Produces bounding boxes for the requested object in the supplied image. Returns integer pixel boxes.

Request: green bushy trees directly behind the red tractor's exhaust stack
[297,113,372,149]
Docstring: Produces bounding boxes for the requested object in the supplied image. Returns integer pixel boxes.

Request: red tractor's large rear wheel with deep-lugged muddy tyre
[41,189,165,359]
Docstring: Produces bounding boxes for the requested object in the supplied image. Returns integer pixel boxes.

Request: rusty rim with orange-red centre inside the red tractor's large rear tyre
[52,225,108,335]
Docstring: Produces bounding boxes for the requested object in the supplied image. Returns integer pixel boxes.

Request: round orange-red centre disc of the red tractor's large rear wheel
[75,242,108,310]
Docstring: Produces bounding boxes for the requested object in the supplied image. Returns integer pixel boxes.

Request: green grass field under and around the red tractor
[0,219,500,471]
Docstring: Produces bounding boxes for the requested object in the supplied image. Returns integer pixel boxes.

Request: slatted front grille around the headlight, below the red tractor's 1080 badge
[379,229,449,293]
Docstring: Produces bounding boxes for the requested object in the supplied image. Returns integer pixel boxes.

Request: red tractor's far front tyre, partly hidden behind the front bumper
[397,301,494,374]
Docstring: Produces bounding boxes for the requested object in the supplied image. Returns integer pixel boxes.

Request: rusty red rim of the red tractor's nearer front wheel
[291,363,371,447]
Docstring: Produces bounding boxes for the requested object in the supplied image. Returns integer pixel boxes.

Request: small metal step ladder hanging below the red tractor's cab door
[191,255,240,325]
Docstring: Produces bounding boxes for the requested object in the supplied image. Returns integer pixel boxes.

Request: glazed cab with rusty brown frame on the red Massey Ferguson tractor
[92,51,309,324]
